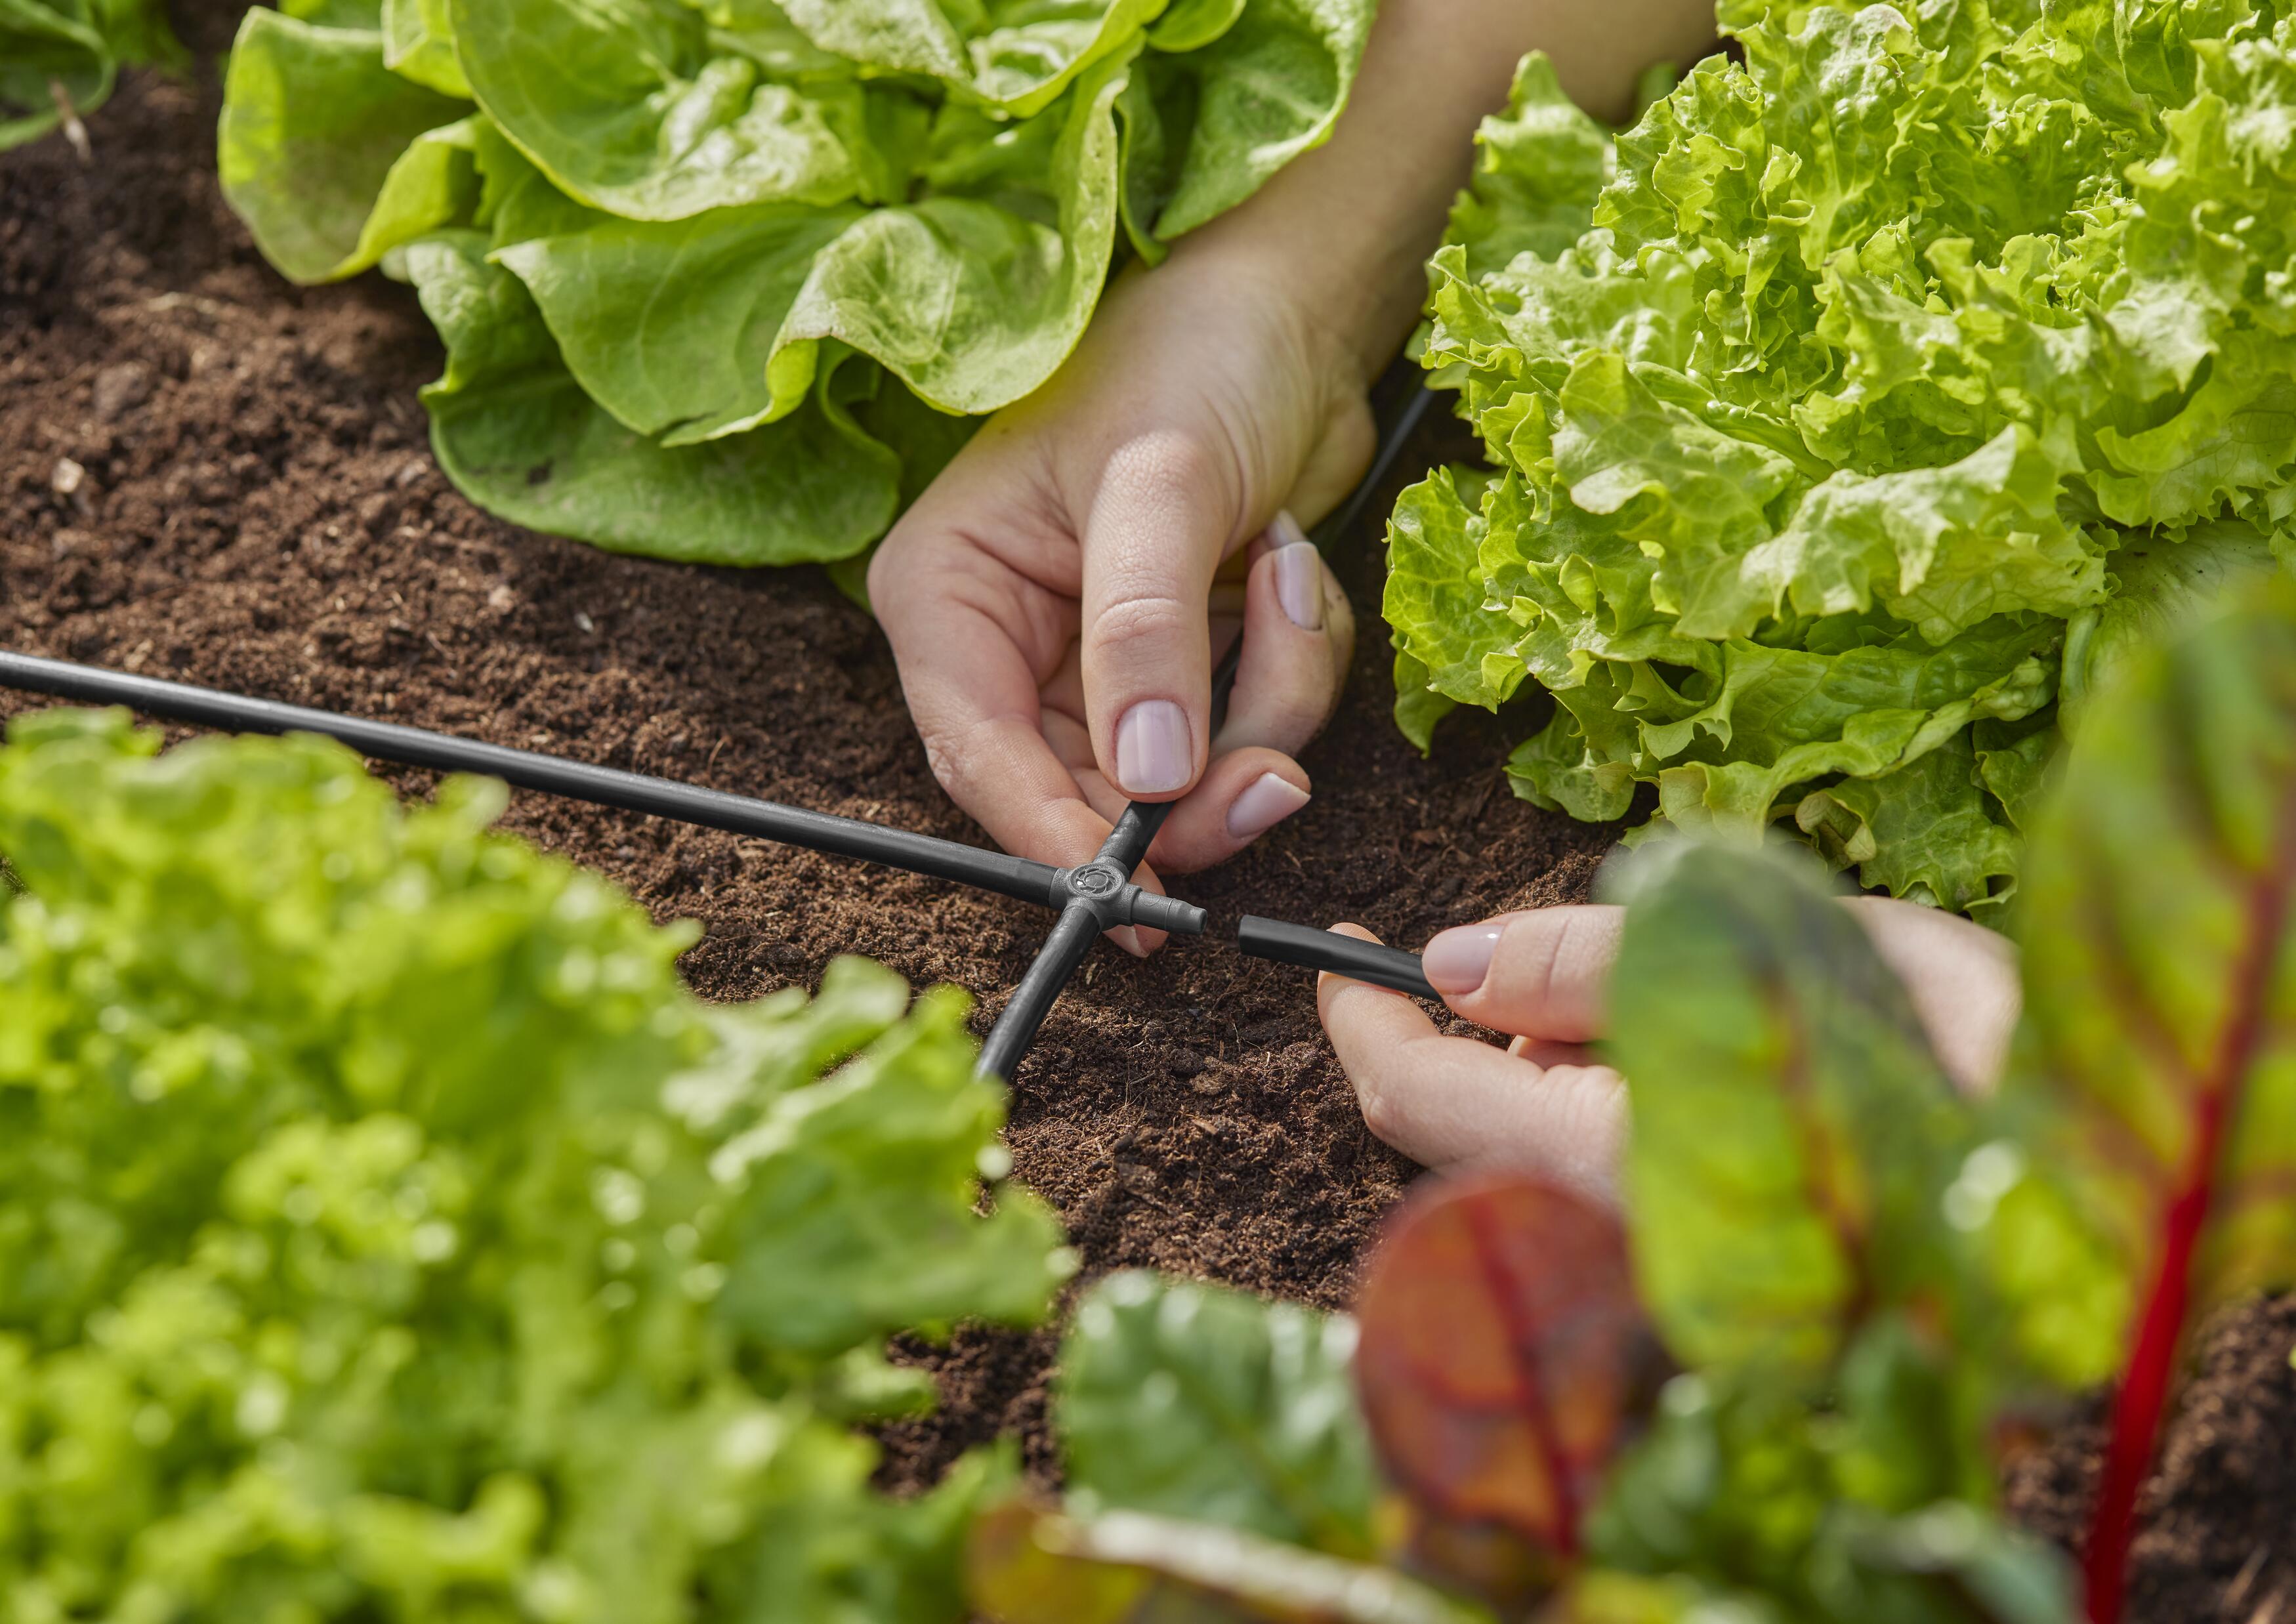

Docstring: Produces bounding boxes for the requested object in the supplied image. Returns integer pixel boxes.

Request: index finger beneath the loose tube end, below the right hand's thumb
[1316,926,1625,1201]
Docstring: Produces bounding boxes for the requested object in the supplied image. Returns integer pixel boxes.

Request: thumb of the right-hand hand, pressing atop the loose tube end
[1421,905,1625,1043]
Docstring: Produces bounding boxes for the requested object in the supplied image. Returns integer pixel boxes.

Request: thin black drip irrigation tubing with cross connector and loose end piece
[0,386,1435,1079]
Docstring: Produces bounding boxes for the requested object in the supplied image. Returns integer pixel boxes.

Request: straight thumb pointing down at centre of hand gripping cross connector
[1079,432,1242,802]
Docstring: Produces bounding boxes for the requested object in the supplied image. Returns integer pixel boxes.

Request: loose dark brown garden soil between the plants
[0,19,2296,1624]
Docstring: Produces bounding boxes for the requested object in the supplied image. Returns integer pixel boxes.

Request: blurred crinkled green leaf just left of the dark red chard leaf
[1054,1272,1377,1557]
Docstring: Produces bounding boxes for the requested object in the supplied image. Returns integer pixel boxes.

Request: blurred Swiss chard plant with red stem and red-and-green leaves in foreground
[971,586,2296,1624]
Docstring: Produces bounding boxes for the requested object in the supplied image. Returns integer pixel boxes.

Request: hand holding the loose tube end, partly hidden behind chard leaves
[1316,896,2023,1199]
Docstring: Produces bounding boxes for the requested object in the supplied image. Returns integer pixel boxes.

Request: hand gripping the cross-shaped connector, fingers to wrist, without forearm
[870,239,1373,932]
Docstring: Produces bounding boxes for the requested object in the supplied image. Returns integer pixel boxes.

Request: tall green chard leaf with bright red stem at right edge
[1968,581,2296,1621]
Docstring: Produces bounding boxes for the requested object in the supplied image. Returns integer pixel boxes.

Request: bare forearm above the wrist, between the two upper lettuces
[1180,0,1713,372]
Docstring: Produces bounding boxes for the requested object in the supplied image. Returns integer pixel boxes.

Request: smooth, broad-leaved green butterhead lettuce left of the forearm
[218,0,1373,563]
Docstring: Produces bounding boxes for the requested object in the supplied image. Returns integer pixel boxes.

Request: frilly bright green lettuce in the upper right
[1387,0,2296,909]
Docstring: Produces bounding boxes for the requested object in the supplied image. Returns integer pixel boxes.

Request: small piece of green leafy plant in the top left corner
[0,0,186,152]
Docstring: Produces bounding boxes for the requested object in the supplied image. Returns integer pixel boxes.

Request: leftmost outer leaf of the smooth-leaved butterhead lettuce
[216,7,478,283]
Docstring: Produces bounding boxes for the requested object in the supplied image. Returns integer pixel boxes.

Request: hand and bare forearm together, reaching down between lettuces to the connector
[870,0,1713,951]
